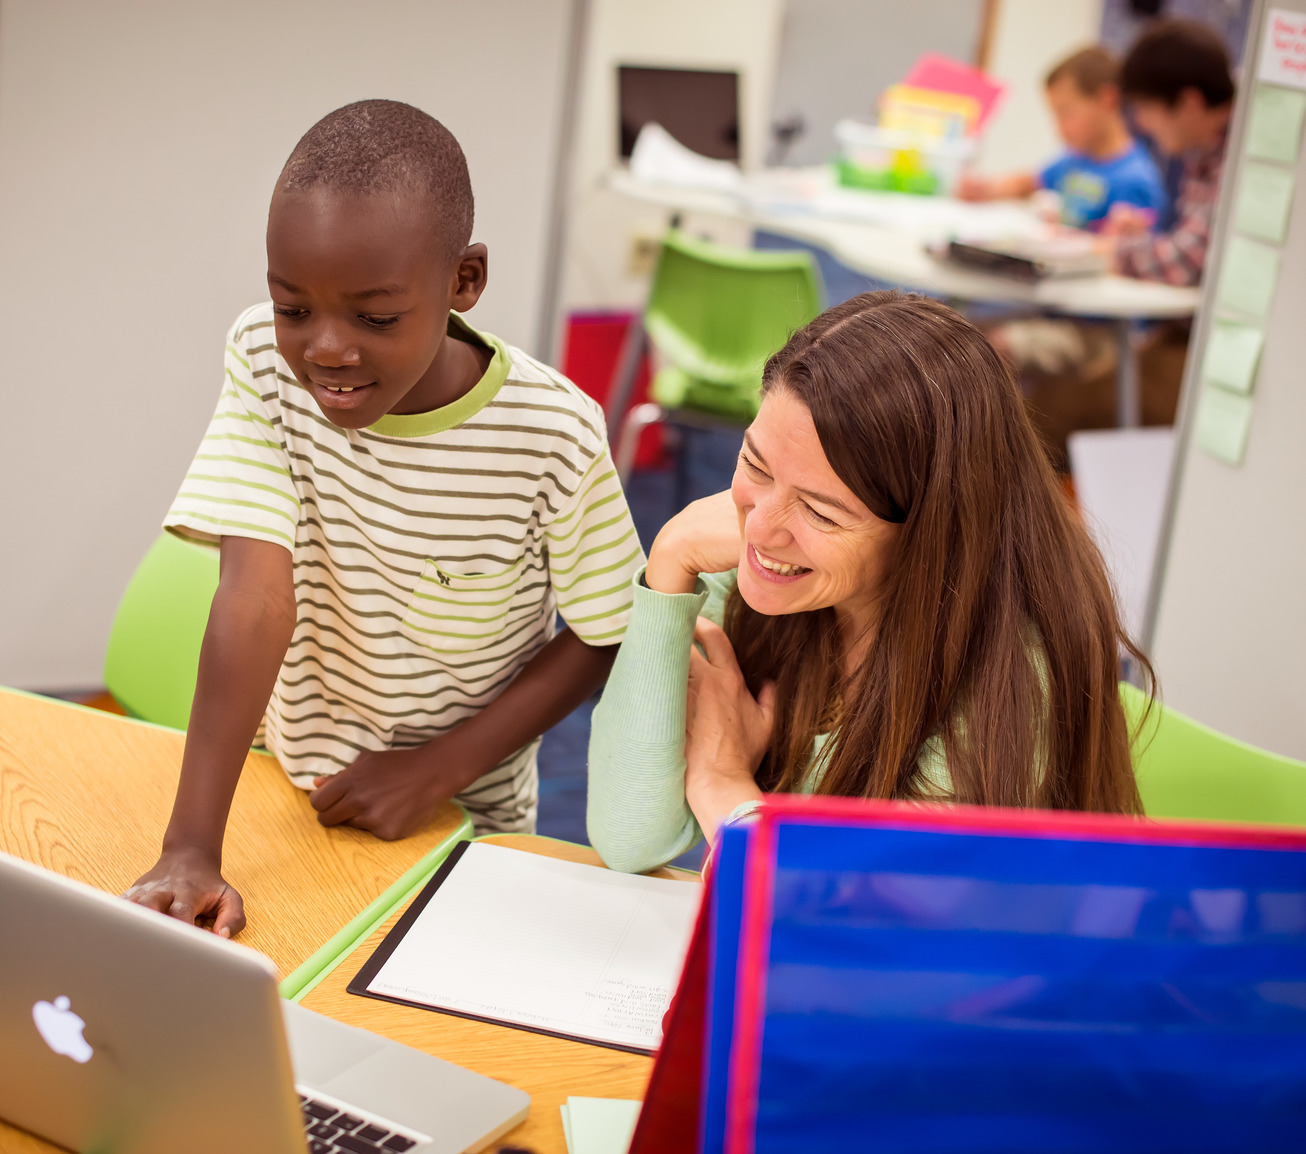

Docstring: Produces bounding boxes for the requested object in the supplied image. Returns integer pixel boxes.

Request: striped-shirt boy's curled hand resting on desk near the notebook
[308,730,486,842]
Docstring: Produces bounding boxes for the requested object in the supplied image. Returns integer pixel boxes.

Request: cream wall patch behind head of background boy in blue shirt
[976,0,1102,172]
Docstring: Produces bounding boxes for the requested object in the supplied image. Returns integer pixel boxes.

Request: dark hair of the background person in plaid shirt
[1121,20,1234,108]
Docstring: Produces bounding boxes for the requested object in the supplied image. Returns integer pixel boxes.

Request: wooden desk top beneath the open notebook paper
[300,834,697,1154]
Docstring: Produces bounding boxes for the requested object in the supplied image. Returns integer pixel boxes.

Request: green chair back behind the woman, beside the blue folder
[1121,684,1306,826]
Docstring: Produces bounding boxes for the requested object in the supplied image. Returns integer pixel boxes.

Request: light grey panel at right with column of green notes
[1152,0,1306,758]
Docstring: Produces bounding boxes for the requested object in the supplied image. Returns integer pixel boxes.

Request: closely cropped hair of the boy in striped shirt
[277,101,475,258]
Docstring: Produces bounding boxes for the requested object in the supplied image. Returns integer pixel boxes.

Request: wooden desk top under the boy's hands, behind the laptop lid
[0,691,464,976]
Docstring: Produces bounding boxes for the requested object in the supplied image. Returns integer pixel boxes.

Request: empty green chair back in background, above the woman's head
[644,231,820,420]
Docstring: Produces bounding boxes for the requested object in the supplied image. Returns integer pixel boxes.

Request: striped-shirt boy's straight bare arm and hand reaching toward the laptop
[127,537,295,937]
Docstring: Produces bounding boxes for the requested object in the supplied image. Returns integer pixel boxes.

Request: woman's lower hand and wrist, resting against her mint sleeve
[684,621,776,842]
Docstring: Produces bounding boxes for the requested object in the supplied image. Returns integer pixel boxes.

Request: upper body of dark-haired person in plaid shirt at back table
[1102,20,1234,285]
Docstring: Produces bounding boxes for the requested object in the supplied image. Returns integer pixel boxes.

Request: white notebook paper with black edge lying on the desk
[349,842,703,1051]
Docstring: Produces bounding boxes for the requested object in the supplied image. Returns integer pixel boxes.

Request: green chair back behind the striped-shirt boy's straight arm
[104,533,218,730]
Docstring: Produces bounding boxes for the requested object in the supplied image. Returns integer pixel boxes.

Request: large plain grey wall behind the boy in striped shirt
[0,0,572,688]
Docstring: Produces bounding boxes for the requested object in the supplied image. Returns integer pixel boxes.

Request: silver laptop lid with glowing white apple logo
[0,854,306,1154]
